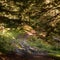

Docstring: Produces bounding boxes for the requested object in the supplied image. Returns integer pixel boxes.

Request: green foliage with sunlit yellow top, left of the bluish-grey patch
[0,29,24,53]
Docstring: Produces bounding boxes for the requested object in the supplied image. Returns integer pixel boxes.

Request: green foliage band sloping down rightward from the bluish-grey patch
[27,37,60,57]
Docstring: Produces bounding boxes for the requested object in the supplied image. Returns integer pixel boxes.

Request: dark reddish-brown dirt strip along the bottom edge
[0,53,55,60]
